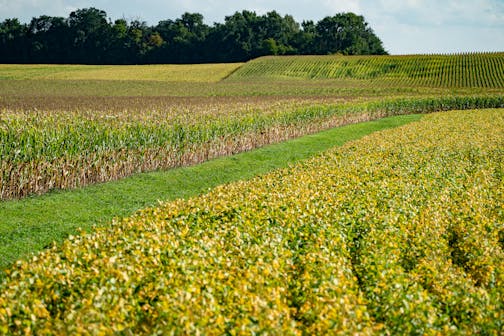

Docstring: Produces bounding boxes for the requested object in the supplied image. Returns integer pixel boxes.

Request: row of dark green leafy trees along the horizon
[0,8,386,64]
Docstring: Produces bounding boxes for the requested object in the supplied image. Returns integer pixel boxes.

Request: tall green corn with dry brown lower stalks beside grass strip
[0,96,504,200]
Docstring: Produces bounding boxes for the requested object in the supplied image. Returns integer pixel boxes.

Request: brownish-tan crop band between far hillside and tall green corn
[0,75,503,98]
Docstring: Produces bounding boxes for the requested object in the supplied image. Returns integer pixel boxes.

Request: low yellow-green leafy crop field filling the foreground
[0,109,504,335]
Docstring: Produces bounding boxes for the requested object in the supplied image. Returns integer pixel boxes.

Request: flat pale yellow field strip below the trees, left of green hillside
[0,63,241,82]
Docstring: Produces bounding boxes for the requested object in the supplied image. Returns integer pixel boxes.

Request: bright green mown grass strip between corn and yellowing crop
[0,115,421,277]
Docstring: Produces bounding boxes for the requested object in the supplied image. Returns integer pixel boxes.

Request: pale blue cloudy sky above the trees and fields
[0,0,504,55]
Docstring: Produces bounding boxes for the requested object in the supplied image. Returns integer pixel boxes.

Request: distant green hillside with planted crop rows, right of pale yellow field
[229,53,504,88]
